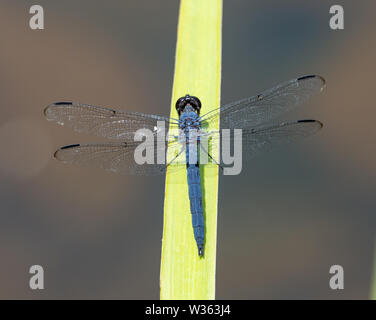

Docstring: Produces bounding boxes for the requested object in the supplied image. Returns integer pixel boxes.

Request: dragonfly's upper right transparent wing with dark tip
[202,75,325,129]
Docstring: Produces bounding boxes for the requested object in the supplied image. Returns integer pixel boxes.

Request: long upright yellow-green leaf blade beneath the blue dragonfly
[160,0,222,299]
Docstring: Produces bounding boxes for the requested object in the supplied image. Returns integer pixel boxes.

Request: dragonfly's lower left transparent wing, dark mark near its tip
[54,136,186,175]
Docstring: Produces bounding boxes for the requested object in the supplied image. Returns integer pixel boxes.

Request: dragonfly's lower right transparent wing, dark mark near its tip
[204,120,323,166]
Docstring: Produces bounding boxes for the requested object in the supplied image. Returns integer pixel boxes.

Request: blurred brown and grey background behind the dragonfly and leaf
[0,0,376,299]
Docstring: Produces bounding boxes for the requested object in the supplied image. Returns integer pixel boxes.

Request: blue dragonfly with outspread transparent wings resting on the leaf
[44,75,325,257]
